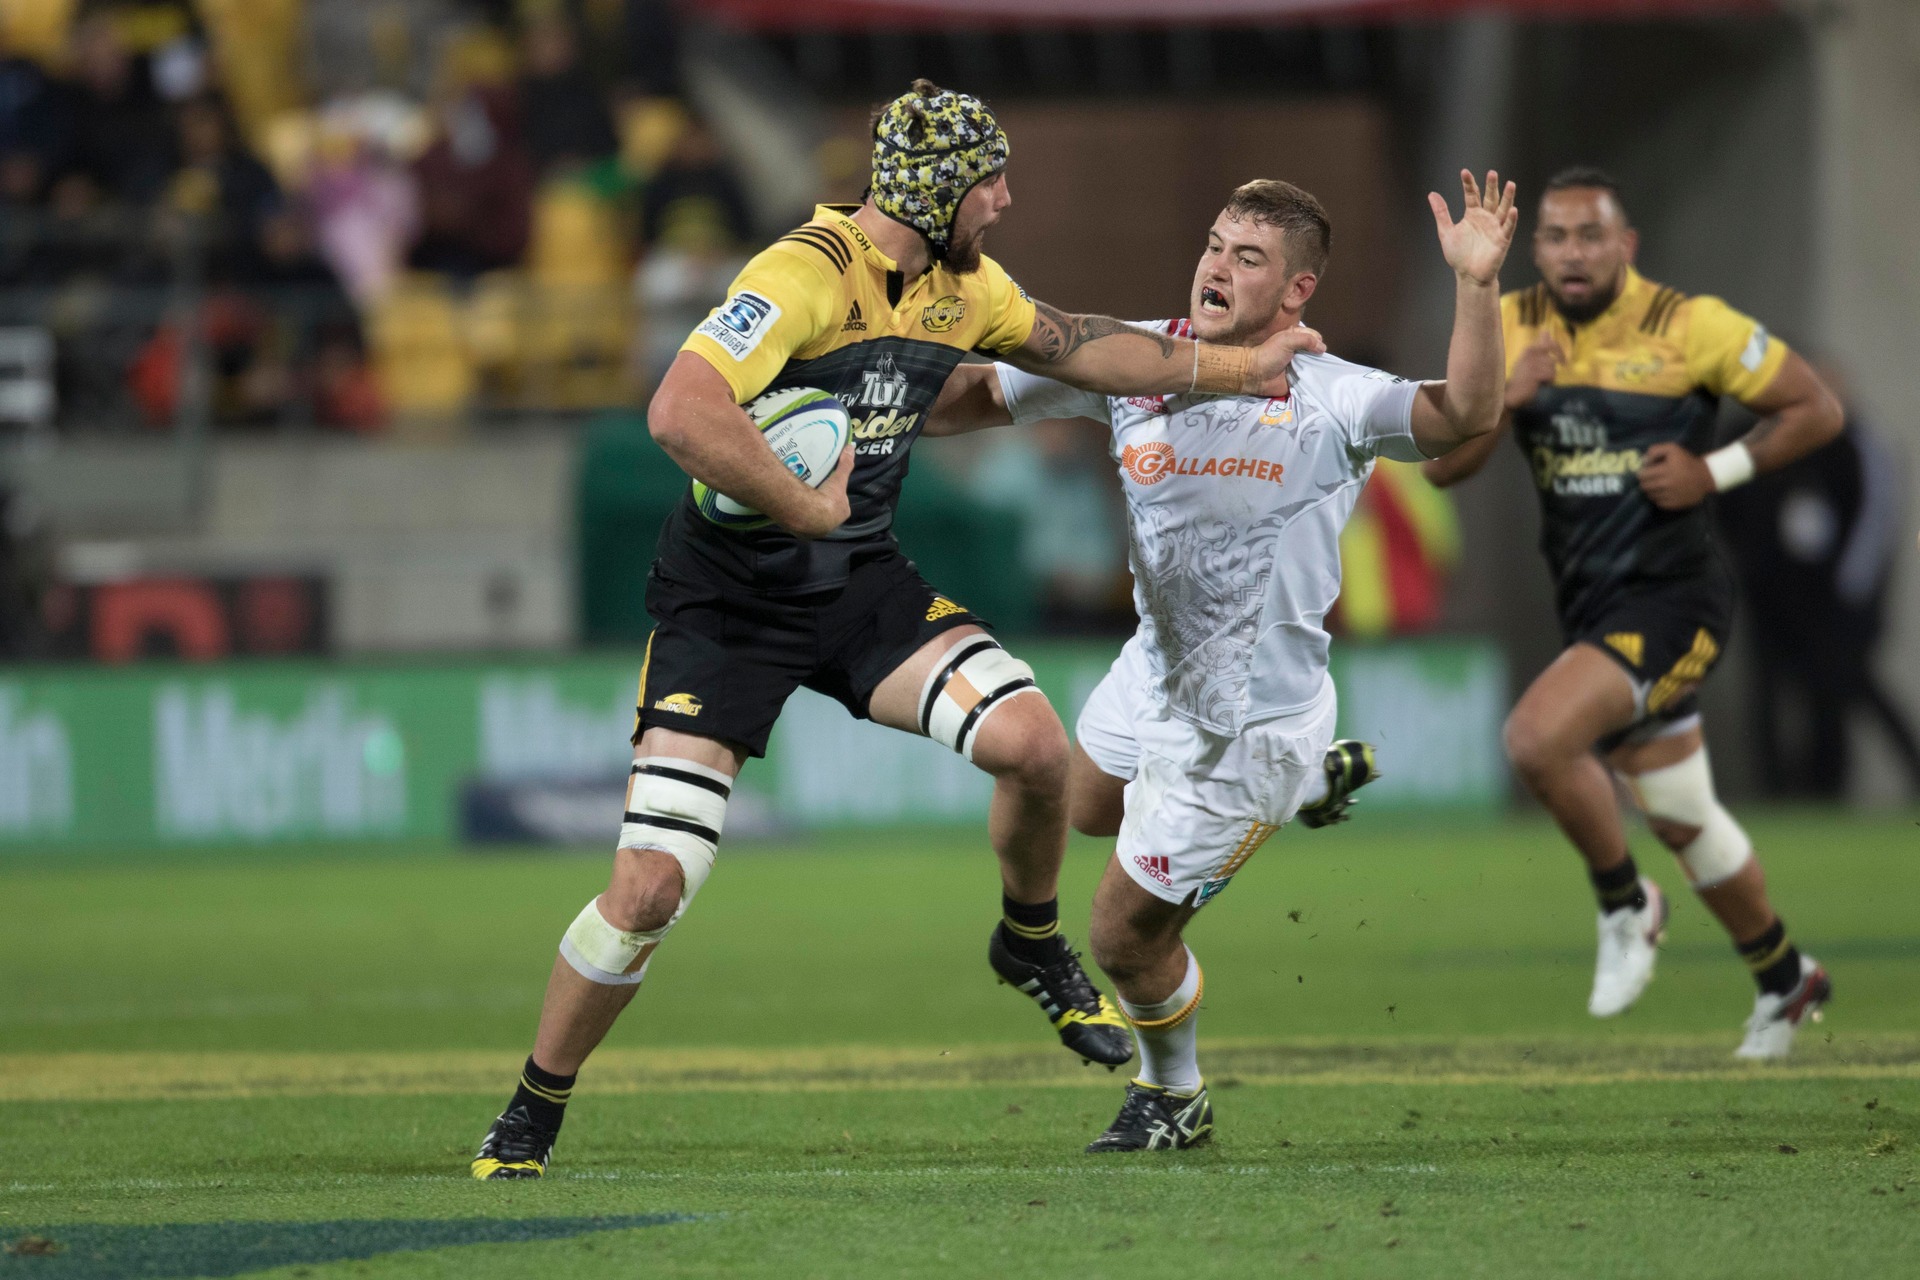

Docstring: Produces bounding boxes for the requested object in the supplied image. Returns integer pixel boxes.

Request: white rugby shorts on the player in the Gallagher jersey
[1081,664,1338,906]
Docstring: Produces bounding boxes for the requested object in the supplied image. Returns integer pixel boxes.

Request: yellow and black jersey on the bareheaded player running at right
[1500,269,1788,628]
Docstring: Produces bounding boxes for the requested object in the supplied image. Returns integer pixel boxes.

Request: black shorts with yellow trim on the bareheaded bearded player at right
[1565,574,1734,752]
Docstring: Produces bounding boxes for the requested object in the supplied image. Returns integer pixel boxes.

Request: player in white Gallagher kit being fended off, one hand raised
[927,171,1517,1151]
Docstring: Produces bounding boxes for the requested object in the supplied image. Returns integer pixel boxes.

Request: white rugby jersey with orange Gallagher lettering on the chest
[998,320,1425,735]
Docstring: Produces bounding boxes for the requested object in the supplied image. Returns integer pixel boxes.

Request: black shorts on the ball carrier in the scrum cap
[634,549,991,756]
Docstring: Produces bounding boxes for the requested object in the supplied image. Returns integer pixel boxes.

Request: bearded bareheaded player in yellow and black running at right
[1425,169,1841,1057]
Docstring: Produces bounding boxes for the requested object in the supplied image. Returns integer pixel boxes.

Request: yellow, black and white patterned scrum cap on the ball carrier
[872,81,1008,261]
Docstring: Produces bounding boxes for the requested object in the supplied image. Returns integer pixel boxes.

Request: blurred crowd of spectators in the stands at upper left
[0,0,753,432]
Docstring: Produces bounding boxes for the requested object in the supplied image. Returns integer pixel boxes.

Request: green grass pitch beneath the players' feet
[0,814,1920,1280]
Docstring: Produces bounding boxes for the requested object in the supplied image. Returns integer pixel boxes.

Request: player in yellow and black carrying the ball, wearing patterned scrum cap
[472,81,1325,1178]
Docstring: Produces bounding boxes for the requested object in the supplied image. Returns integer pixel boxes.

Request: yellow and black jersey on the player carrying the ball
[660,205,1033,595]
